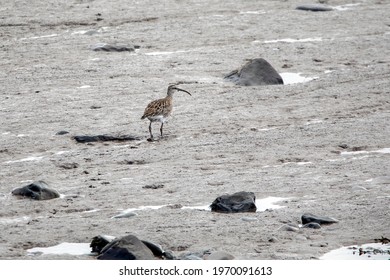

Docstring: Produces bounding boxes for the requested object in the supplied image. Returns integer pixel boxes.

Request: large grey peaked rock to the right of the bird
[224,58,283,86]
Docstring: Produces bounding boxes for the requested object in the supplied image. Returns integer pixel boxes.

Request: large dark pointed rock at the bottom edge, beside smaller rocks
[98,235,155,260]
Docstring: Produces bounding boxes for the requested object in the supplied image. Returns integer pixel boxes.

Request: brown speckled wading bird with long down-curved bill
[141,84,191,140]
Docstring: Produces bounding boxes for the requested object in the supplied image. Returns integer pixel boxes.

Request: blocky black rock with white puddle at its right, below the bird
[210,192,257,213]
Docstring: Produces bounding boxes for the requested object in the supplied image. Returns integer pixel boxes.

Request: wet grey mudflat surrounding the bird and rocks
[0,0,390,259]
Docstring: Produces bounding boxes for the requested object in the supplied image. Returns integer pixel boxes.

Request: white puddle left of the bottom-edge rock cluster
[27,242,92,256]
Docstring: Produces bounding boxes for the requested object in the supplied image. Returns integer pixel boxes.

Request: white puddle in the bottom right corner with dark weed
[320,243,390,260]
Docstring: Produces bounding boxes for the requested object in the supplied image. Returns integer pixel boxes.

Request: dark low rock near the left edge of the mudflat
[12,181,60,200]
